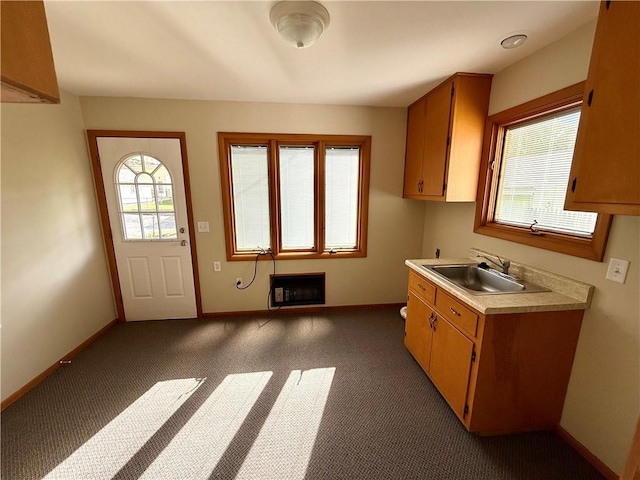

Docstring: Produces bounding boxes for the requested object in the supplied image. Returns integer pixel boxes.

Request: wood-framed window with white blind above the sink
[474,83,611,261]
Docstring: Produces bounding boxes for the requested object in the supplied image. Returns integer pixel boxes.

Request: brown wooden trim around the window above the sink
[473,82,613,262]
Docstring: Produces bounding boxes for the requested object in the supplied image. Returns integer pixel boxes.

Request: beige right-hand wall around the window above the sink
[422,24,640,473]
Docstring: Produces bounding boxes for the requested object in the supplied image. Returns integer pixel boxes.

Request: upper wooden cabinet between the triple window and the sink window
[403,73,492,202]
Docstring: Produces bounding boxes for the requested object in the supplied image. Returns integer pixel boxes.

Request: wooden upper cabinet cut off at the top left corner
[0,0,60,103]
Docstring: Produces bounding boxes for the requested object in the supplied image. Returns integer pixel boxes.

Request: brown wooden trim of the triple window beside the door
[218,132,371,261]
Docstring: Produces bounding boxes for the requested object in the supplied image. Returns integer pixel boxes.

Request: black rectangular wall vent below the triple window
[271,272,324,307]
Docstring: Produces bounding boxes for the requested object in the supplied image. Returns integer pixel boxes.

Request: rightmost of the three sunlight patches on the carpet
[236,367,336,480]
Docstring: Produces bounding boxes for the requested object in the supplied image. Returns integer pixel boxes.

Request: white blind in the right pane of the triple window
[324,147,360,251]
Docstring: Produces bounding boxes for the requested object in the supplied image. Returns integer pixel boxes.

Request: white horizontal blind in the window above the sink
[494,107,598,236]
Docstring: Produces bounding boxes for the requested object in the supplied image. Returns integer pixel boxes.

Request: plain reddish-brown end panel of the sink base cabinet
[463,310,583,434]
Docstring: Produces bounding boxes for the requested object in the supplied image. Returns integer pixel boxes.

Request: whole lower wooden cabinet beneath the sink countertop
[404,270,583,434]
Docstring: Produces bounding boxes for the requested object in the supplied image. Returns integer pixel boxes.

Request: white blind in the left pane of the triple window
[231,145,271,252]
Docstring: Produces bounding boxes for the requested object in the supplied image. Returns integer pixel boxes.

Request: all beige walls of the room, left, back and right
[1,16,640,472]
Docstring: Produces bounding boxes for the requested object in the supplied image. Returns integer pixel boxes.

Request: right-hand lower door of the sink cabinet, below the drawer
[429,316,473,418]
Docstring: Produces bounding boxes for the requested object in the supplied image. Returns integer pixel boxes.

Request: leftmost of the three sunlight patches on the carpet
[44,378,206,480]
